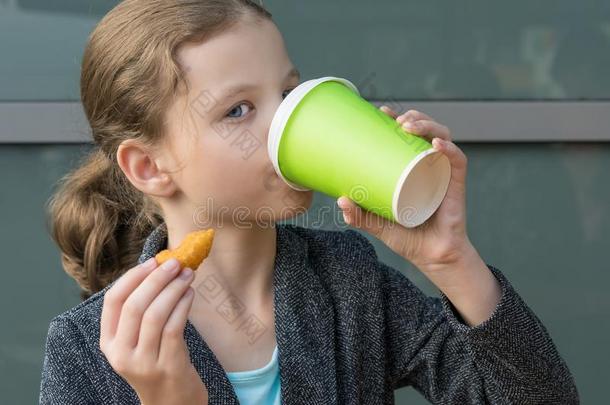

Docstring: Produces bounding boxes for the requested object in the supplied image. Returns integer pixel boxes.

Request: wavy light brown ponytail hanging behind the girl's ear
[48,149,162,300]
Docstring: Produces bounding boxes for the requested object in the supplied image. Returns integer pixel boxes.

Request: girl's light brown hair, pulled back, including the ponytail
[48,0,272,300]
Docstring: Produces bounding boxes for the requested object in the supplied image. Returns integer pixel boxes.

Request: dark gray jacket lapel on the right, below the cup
[273,225,337,404]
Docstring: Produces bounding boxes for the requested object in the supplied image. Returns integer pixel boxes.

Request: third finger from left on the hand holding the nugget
[137,268,193,358]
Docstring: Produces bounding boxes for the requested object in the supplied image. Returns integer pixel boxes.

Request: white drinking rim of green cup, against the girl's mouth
[267,76,360,191]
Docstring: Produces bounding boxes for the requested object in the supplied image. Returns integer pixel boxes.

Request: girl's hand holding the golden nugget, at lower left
[100,258,208,405]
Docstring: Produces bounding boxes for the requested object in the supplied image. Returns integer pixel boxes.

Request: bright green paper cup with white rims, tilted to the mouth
[267,77,451,228]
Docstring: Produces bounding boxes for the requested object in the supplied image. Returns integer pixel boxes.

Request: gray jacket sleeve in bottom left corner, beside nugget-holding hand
[39,316,102,405]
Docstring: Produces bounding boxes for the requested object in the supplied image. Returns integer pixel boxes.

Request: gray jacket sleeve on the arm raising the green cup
[377,261,579,404]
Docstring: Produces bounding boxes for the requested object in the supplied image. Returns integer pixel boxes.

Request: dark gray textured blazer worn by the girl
[40,224,579,405]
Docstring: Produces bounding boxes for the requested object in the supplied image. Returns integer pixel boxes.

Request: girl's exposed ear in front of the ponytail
[117,139,177,197]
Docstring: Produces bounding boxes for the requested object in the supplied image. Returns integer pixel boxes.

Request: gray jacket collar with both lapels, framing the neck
[138,223,337,404]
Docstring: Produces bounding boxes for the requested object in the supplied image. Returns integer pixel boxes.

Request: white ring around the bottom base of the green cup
[392,148,451,228]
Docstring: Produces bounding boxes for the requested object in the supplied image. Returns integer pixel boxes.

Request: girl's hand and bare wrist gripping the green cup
[337,106,502,326]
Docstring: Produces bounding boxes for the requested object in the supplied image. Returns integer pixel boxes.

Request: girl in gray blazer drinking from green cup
[40,0,578,405]
